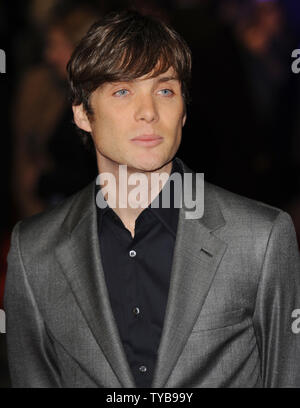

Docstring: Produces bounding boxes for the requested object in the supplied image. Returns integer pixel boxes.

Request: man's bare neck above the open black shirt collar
[98,156,172,236]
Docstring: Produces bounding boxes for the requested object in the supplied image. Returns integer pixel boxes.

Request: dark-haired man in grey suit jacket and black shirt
[5,8,300,387]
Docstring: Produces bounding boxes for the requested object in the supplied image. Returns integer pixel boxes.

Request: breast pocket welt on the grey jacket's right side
[192,309,247,333]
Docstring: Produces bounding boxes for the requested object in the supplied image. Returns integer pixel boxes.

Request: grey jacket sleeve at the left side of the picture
[4,222,61,388]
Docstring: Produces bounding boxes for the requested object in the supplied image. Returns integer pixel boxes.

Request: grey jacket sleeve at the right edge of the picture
[253,212,300,388]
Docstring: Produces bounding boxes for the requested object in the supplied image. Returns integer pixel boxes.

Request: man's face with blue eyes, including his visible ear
[73,68,185,171]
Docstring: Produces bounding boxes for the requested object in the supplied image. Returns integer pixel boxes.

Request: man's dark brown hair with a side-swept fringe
[67,11,192,148]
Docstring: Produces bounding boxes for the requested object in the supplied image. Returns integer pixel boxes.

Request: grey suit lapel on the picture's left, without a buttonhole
[56,182,135,387]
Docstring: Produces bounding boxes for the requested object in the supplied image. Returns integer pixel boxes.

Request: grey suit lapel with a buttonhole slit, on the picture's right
[152,162,227,387]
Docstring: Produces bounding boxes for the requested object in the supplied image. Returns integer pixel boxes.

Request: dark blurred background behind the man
[0,0,300,387]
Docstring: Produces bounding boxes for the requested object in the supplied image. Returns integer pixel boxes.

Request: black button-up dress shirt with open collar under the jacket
[96,161,181,387]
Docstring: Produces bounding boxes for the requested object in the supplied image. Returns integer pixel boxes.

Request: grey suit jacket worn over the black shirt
[5,159,300,387]
